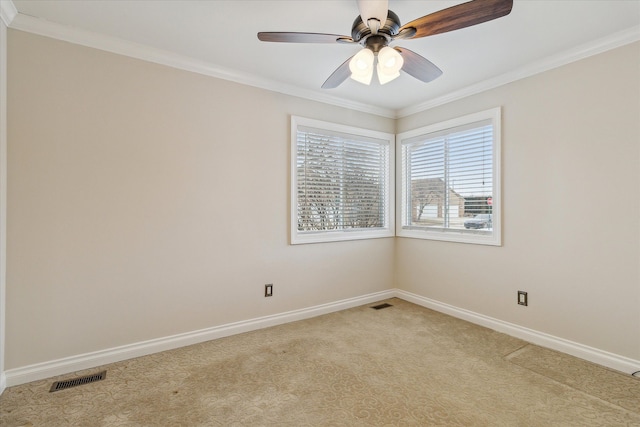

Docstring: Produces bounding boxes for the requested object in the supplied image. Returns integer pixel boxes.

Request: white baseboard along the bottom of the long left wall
[2,290,395,387]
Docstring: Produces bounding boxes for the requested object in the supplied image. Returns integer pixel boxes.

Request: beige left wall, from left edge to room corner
[6,30,395,369]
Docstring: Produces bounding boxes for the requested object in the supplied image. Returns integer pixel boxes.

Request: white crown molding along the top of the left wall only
[7,12,396,118]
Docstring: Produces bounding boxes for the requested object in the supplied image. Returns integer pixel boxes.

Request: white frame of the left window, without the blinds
[289,116,396,245]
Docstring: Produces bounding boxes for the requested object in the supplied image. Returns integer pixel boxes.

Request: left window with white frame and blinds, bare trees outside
[291,117,394,244]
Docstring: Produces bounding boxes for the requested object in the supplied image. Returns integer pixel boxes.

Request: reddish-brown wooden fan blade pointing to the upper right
[400,0,513,39]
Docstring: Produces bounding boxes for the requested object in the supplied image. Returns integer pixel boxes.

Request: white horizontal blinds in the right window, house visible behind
[403,120,493,230]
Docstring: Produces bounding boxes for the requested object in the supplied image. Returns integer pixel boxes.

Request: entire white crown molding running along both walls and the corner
[0,5,640,119]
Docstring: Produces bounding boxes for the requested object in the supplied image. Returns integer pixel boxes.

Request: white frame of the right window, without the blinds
[396,107,502,246]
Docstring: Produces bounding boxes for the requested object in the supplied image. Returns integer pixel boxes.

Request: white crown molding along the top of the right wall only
[395,26,640,118]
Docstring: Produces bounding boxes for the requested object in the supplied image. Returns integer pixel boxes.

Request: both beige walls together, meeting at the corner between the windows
[5,30,640,369]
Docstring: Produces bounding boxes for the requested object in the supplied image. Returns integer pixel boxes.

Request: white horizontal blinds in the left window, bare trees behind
[296,126,389,232]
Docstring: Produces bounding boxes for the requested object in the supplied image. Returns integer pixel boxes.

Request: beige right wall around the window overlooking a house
[396,43,640,360]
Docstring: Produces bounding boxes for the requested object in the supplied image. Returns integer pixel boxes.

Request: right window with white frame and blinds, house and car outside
[397,108,501,245]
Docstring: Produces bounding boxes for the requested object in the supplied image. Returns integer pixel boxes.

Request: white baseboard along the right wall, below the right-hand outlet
[395,289,640,374]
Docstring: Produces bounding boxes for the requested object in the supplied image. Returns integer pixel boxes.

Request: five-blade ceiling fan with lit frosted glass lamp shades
[258,0,513,89]
